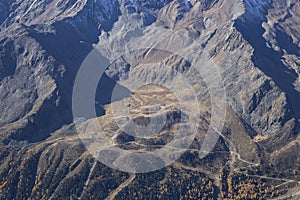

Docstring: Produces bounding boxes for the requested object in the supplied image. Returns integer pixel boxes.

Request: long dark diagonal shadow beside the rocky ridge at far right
[235,17,300,123]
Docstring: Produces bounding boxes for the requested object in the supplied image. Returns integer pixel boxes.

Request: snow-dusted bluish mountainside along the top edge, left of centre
[0,0,119,26]
